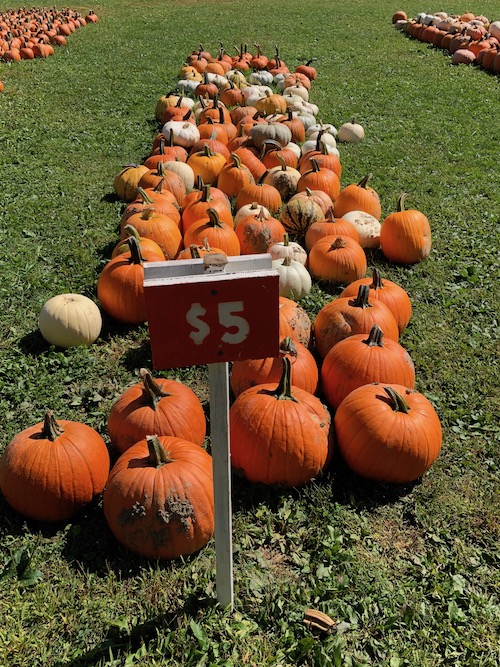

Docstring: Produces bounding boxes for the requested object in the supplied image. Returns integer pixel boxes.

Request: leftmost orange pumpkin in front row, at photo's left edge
[0,410,109,521]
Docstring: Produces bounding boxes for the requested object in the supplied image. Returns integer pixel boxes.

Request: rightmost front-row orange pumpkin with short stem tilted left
[335,384,442,483]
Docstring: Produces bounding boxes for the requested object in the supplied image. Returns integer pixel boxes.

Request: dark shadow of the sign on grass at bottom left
[54,589,217,667]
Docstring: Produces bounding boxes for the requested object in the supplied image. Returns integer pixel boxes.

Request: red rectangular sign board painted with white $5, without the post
[144,270,279,370]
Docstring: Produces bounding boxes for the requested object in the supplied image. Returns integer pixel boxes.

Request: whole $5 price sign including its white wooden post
[144,254,279,608]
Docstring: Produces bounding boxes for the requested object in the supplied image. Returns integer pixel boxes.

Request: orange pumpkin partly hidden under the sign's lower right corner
[231,337,318,397]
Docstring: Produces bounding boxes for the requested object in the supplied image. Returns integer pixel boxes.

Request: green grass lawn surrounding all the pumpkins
[0,0,500,667]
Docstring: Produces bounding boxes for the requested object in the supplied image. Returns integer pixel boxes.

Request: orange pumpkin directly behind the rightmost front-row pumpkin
[321,324,415,409]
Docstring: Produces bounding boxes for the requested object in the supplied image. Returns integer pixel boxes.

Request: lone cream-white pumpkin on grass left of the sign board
[38,294,102,348]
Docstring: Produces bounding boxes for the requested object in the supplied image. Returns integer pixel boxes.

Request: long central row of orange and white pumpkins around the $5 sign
[0,46,441,558]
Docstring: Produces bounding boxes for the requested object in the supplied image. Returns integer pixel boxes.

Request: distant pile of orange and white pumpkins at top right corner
[392,11,500,73]
